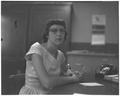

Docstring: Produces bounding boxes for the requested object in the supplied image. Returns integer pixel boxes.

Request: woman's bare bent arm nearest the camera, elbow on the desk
[32,54,79,88]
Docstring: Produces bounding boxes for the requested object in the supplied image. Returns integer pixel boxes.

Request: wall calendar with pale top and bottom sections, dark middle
[91,15,106,45]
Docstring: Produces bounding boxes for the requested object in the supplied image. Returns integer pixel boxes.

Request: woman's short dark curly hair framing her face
[43,19,67,43]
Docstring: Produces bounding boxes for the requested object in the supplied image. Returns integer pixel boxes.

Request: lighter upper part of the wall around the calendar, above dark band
[71,2,119,43]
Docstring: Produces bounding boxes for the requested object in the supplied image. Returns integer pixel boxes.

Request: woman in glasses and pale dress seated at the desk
[19,20,82,94]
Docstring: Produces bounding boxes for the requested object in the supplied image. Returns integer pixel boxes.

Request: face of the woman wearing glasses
[48,24,65,45]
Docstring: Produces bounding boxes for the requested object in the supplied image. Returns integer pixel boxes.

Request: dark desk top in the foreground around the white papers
[49,80,119,95]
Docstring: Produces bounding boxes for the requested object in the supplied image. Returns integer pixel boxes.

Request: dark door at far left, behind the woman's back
[1,3,28,94]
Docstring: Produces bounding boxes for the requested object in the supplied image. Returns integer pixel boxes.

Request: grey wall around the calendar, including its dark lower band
[71,1,119,53]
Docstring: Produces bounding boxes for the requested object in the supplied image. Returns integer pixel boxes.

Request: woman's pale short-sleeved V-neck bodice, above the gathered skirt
[20,42,65,92]
